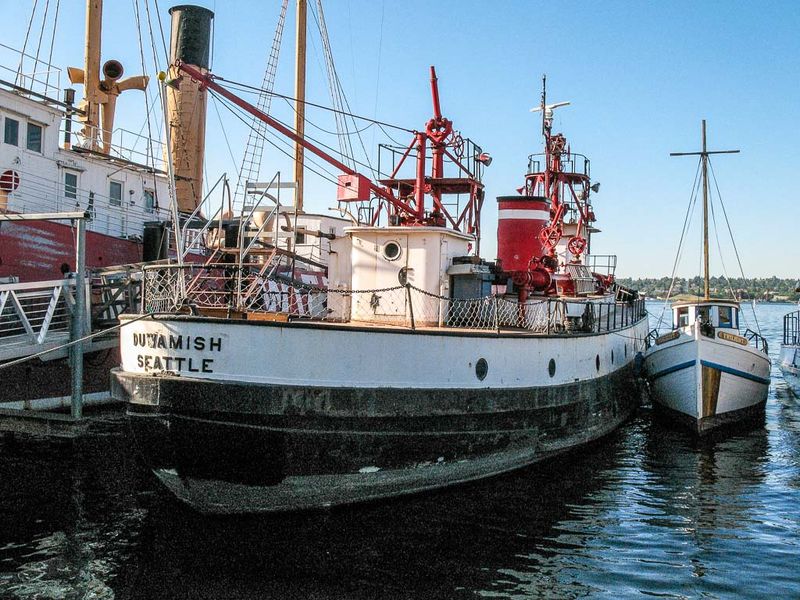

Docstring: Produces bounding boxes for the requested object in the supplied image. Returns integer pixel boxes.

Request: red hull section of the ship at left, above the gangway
[0,221,142,282]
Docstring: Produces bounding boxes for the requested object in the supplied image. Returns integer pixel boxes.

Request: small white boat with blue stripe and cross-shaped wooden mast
[644,121,770,435]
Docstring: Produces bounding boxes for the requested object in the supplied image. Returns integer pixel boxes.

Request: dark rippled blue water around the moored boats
[0,305,800,599]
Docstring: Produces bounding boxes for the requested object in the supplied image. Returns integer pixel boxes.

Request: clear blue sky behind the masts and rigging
[3,0,800,278]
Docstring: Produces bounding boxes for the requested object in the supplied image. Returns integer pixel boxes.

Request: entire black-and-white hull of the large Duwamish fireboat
[112,318,646,513]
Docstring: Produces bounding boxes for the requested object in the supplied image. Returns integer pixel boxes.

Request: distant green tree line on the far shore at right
[617,276,800,302]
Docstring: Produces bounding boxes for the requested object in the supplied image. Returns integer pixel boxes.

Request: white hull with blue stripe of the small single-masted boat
[645,328,770,433]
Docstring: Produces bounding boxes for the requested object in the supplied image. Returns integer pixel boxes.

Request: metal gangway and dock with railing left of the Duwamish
[0,212,139,437]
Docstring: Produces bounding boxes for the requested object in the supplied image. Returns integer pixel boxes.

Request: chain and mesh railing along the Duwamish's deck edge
[143,263,646,334]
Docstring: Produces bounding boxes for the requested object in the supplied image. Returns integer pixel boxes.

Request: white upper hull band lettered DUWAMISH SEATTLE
[120,316,647,390]
